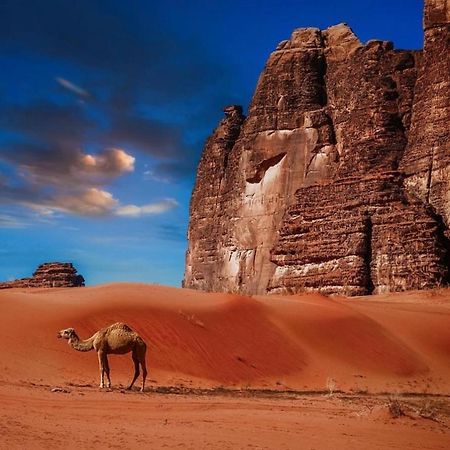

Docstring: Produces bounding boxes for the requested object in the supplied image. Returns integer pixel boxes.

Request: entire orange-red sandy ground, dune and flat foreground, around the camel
[0,283,450,449]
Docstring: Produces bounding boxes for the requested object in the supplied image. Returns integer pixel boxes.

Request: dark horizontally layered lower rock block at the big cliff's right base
[268,172,447,295]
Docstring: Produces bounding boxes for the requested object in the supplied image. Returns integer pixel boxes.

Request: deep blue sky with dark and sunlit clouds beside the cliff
[0,0,423,286]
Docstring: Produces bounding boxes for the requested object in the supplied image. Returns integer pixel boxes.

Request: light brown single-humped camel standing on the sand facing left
[58,322,147,392]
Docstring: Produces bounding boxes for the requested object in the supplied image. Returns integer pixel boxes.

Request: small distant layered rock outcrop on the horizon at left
[0,262,84,289]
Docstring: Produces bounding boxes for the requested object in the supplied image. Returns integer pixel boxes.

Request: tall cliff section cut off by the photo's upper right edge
[401,0,450,237]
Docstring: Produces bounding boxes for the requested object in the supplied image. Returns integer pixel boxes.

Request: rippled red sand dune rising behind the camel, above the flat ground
[0,283,450,393]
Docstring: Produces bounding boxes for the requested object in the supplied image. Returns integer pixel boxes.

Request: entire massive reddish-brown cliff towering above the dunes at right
[184,0,450,295]
